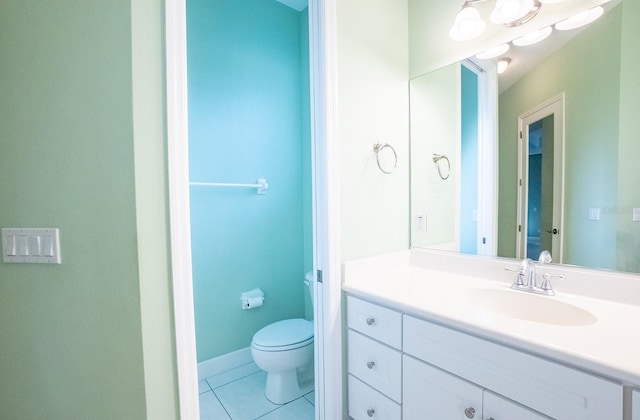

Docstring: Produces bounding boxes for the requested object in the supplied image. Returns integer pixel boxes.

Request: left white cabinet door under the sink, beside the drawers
[402,356,482,420]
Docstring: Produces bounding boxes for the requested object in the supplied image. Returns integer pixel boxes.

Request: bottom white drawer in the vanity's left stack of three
[349,375,402,420]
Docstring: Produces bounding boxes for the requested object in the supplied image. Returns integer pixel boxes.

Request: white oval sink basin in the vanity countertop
[465,289,597,326]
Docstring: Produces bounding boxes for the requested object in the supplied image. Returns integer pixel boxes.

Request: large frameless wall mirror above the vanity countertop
[410,0,640,272]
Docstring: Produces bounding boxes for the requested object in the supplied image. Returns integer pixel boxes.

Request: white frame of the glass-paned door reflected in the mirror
[516,92,565,263]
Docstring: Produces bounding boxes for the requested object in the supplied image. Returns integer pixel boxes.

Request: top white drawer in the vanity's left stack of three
[347,296,402,349]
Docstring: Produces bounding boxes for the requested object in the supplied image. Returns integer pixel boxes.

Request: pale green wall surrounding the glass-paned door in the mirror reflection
[498,2,630,268]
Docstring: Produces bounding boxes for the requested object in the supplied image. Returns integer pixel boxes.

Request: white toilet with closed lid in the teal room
[251,273,314,404]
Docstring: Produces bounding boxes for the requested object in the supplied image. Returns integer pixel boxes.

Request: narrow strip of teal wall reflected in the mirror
[460,66,478,254]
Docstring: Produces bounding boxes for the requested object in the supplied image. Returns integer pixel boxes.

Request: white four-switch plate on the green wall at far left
[2,228,62,264]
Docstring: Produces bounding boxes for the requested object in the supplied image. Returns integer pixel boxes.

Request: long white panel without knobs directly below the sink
[403,315,623,420]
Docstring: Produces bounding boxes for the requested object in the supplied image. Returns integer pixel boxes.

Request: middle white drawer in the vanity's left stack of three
[349,330,402,402]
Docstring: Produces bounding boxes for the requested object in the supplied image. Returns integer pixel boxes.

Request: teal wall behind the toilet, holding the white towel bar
[187,0,312,361]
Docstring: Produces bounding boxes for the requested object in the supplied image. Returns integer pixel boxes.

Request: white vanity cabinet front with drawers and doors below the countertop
[347,296,624,420]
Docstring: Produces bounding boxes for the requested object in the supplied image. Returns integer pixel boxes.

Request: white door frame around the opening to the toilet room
[165,0,343,420]
